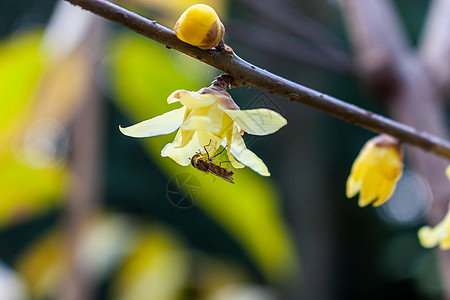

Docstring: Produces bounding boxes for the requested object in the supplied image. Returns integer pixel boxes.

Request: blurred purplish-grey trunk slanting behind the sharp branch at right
[343,0,450,299]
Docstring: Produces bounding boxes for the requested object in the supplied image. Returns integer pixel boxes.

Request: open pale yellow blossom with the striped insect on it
[119,86,287,176]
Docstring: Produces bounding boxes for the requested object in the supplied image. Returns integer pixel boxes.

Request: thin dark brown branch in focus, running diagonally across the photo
[66,0,450,162]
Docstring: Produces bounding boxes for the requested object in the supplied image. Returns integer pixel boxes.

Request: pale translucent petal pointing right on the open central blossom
[218,104,287,135]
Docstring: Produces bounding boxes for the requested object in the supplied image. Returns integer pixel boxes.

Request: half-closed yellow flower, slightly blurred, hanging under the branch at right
[347,134,403,207]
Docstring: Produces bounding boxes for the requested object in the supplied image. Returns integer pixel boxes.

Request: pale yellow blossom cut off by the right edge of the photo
[417,166,450,250]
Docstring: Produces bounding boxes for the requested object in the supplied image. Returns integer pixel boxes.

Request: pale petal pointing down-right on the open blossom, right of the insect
[230,128,270,176]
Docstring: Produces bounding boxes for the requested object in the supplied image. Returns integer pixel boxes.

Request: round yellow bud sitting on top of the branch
[175,4,225,50]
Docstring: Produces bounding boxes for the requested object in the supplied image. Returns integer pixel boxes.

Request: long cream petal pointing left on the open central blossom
[119,107,186,138]
